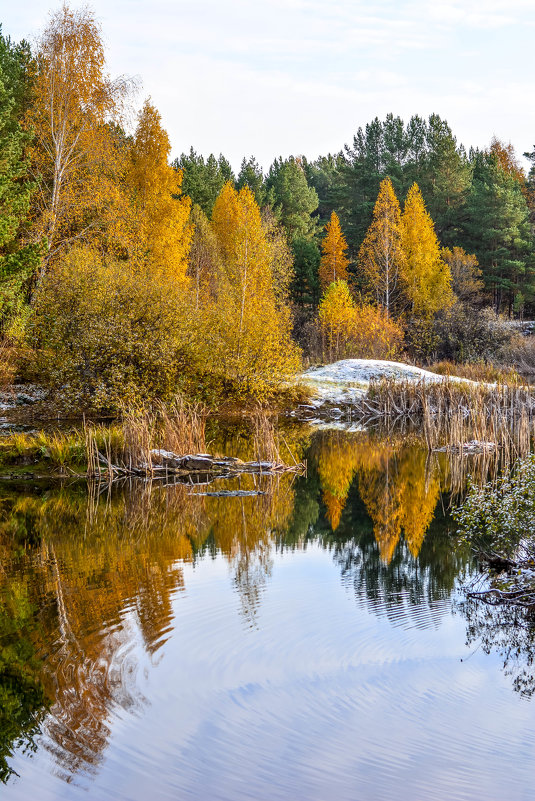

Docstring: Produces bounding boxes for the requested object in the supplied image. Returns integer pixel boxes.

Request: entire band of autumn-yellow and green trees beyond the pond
[0,5,535,409]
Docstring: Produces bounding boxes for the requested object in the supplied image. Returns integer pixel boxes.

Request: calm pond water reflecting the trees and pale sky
[0,429,535,801]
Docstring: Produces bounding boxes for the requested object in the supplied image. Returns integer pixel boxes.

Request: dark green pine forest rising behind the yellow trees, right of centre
[178,119,535,316]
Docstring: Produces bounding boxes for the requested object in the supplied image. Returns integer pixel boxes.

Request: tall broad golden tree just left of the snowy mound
[209,182,300,396]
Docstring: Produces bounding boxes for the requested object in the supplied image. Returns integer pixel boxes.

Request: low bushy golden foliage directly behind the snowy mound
[318,281,403,361]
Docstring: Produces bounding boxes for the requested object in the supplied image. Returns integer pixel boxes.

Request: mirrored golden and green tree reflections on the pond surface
[0,428,520,792]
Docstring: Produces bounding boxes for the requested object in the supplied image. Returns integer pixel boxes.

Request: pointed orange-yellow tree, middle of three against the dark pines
[358,178,405,313]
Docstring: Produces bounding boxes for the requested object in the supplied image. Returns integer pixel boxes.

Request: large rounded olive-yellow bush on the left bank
[32,248,203,411]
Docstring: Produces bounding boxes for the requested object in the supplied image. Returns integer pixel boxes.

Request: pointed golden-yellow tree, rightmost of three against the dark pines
[401,184,453,318]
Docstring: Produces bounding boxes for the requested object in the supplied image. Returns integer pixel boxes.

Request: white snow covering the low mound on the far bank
[300,359,475,406]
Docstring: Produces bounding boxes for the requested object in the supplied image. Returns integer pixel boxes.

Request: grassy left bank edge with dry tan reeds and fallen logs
[0,403,306,483]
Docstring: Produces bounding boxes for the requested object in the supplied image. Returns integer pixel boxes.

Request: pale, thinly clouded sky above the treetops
[0,0,535,170]
